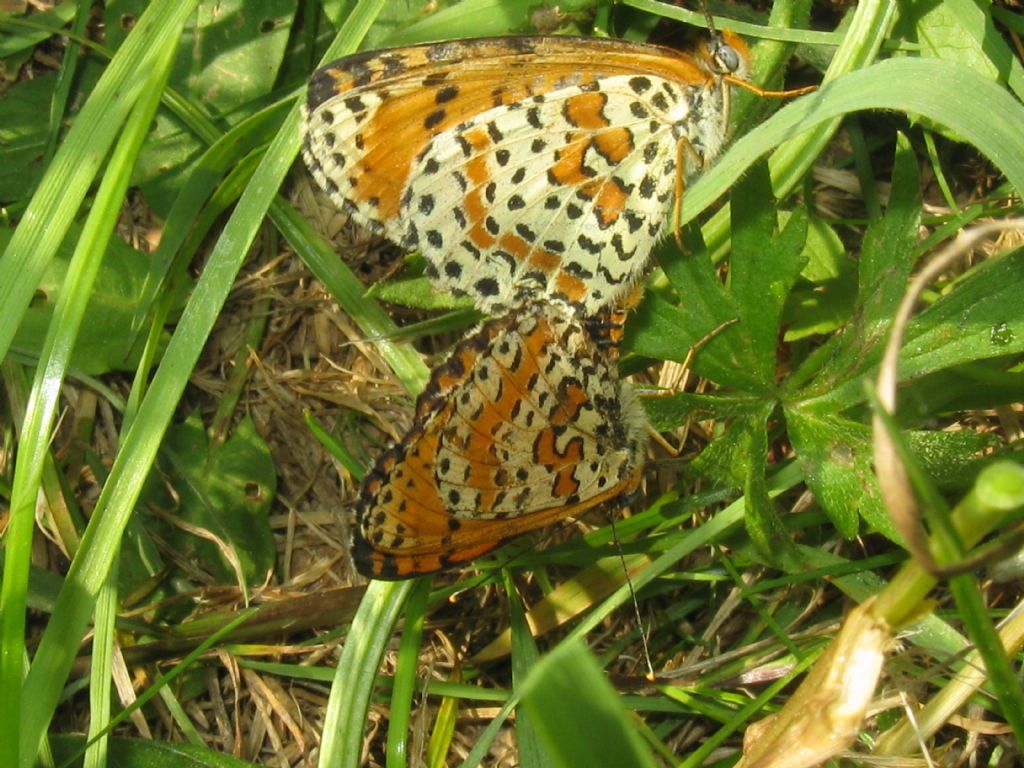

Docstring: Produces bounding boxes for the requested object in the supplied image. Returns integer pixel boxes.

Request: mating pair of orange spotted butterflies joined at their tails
[303,25,748,579]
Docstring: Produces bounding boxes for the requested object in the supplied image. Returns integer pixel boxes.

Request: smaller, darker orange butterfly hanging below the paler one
[352,299,646,580]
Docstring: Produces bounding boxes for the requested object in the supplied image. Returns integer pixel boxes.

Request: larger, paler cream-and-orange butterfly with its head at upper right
[303,36,749,313]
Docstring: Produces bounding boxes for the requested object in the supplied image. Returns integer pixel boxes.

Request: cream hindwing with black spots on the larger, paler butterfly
[401,69,725,312]
